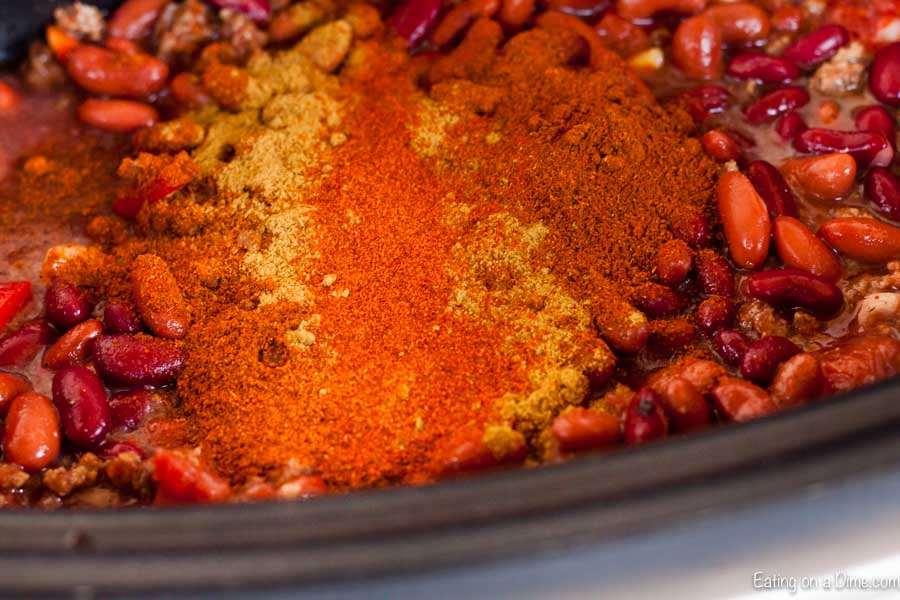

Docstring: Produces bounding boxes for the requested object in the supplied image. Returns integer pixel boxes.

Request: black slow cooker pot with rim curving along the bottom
[0,0,900,597]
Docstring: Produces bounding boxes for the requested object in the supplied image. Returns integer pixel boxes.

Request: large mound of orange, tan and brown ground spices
[167,14,714,489]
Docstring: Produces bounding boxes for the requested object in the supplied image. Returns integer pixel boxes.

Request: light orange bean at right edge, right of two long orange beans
[819,217,900,263]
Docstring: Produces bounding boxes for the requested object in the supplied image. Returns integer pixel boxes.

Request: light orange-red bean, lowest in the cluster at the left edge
[3,392,59,473]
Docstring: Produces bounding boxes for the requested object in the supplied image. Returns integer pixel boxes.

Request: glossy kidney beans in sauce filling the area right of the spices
[391,0,900,455]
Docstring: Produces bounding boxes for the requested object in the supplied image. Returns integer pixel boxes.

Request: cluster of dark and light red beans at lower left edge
[0,280,178,482]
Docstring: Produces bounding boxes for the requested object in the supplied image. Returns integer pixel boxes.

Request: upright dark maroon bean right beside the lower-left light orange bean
[53,366,109,450]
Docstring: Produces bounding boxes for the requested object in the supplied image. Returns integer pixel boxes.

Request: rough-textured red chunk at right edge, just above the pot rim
[816,335,900,394]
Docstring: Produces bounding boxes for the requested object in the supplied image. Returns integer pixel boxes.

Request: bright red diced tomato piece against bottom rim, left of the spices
[153,448,231,504]
